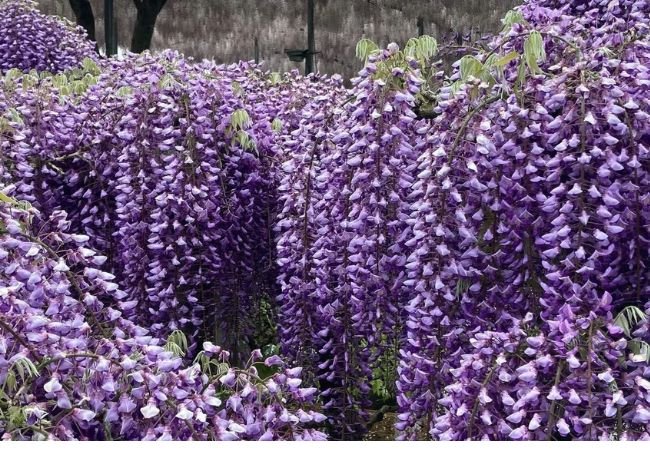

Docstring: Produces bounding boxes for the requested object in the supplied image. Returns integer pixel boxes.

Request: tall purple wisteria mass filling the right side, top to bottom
[397,2,650,439]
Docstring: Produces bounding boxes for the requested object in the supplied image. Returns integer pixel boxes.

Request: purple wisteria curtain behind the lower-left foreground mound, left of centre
[0,52,340,363]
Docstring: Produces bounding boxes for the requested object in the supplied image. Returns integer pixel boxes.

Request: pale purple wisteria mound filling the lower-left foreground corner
[0,194,325,440]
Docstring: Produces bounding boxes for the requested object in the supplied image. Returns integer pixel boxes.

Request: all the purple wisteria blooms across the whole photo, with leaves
[0,0,650,440]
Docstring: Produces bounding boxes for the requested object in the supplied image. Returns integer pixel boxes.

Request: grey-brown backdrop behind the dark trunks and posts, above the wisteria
[39,0,521,78]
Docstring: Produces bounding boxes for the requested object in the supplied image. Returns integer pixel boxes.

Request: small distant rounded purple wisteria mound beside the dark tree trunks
[0,0,96,74]
